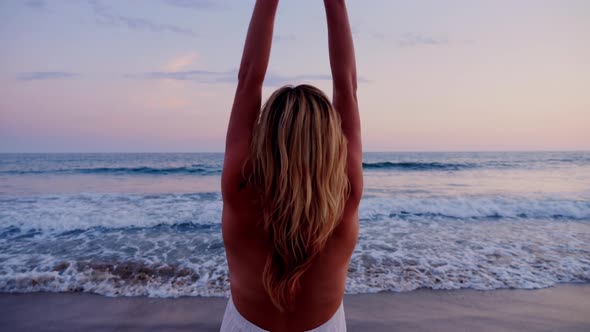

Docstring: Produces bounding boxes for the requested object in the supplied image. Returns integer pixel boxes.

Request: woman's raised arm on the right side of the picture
[324,0,363,199]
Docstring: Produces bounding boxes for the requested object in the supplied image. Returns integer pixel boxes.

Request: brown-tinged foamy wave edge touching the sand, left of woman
[0,255,229,297]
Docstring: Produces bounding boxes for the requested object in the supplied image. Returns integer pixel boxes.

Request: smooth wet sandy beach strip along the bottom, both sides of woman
[0,284,590,332]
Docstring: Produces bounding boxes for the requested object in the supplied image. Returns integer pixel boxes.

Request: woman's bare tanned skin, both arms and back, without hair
[222,0,363,331]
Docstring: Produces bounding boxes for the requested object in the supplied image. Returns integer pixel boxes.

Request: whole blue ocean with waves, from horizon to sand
[0,152,590,297]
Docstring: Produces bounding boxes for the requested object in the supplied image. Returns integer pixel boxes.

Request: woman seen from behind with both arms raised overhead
[221,0,363,331]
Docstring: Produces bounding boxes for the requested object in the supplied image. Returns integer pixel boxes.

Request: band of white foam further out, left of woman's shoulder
[0,193,222,232]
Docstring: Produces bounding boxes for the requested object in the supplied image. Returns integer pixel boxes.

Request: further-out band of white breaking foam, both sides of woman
[0,193,590,232]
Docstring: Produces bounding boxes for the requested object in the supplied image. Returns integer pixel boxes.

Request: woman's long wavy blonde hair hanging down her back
[249,85,350,311]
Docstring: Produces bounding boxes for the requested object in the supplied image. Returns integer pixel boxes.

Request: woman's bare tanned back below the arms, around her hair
[222,183,358,331]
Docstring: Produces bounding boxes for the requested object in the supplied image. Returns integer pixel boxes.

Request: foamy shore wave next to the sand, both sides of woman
[0,220,590,297]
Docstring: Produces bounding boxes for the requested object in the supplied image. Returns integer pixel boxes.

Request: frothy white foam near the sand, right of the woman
[347,220,590,293]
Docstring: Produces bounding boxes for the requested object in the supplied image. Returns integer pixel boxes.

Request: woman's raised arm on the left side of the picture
[222,0,279,192]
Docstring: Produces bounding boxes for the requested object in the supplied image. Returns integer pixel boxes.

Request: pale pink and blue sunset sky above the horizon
[0,0,590,152]
